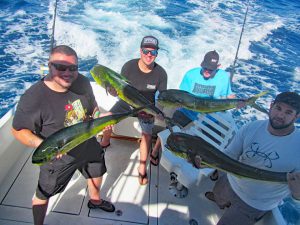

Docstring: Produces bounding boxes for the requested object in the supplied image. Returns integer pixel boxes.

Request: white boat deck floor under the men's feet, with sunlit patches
[0,132,221,225]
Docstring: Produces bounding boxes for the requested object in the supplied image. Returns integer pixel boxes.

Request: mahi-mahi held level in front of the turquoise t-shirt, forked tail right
[157,89,268,113]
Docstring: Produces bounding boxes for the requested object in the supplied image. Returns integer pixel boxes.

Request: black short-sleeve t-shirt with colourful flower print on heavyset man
[13,75,99,159]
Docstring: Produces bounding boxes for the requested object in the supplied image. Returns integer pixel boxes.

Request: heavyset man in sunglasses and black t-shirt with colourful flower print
[12,45,115,225]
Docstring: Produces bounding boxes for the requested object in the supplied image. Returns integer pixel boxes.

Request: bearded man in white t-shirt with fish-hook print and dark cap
[202,92,300,225]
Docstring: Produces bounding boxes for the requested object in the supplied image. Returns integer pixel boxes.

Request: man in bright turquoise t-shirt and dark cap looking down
[151,50,235,173]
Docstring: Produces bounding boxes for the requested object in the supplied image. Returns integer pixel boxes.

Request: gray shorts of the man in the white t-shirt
[213,173,267,225]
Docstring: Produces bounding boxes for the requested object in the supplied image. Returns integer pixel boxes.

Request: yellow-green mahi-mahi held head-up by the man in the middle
[90,64,163,115]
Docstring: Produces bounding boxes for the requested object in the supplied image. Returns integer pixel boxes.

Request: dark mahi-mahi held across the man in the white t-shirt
[167,132,287,183]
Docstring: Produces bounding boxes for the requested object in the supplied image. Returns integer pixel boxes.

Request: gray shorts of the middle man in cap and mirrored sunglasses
[109,100,154,135]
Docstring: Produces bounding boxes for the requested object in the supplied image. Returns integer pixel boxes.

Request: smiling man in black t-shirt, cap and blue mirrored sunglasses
[101,36,167,185]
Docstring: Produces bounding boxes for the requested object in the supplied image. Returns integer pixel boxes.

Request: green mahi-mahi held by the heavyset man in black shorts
[32,107,143,165]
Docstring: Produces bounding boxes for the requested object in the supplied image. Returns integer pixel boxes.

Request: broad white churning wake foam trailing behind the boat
[49,1,282,93]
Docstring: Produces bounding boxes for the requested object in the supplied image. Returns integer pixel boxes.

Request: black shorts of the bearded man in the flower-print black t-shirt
[35,151,106,200]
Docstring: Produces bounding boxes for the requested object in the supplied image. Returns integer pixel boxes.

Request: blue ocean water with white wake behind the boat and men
[0,0,300,125]
